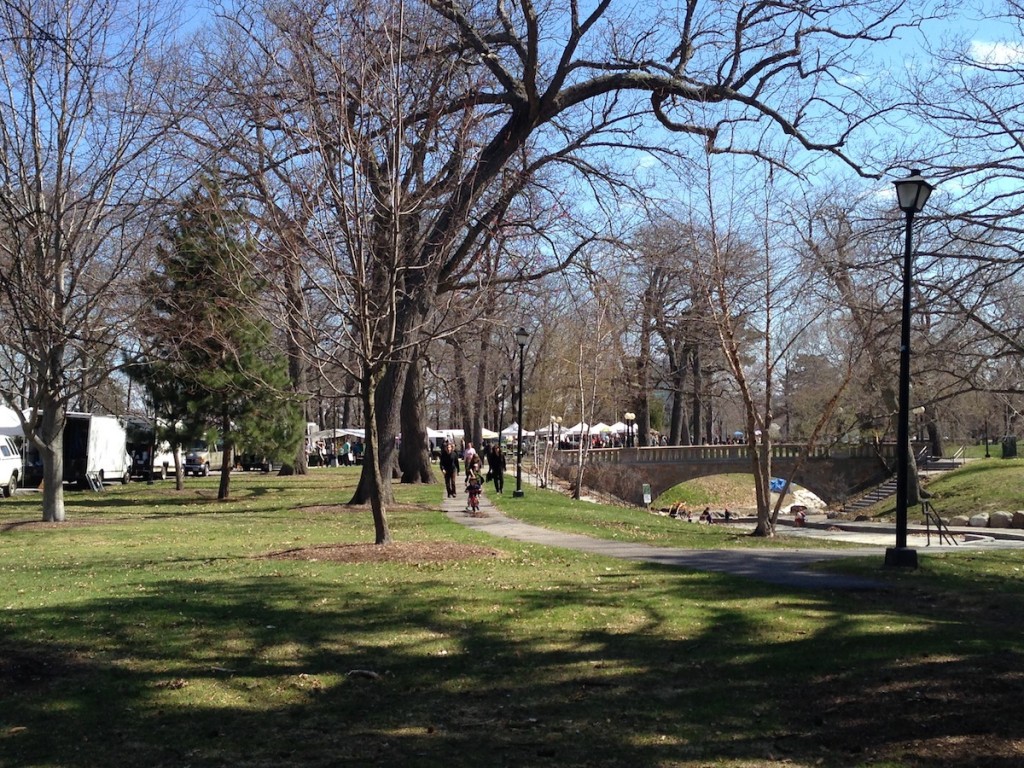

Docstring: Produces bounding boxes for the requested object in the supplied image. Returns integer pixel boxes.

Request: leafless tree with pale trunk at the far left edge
[0,0,186,521]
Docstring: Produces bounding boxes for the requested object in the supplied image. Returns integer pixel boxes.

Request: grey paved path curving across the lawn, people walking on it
[442,483,886,590]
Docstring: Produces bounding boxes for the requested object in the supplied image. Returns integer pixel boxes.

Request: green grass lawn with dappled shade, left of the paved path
[0,469,1024,768]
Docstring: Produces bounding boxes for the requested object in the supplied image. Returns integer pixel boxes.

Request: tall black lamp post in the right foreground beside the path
[886,170,933,568]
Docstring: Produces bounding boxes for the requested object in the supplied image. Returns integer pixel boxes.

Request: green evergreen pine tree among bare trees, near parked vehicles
[136,183,304,499]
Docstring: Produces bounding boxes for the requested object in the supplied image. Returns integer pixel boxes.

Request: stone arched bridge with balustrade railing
[553,443,896,504]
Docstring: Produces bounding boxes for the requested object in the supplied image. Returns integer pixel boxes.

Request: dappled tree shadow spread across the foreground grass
[0,558,1024,768]
